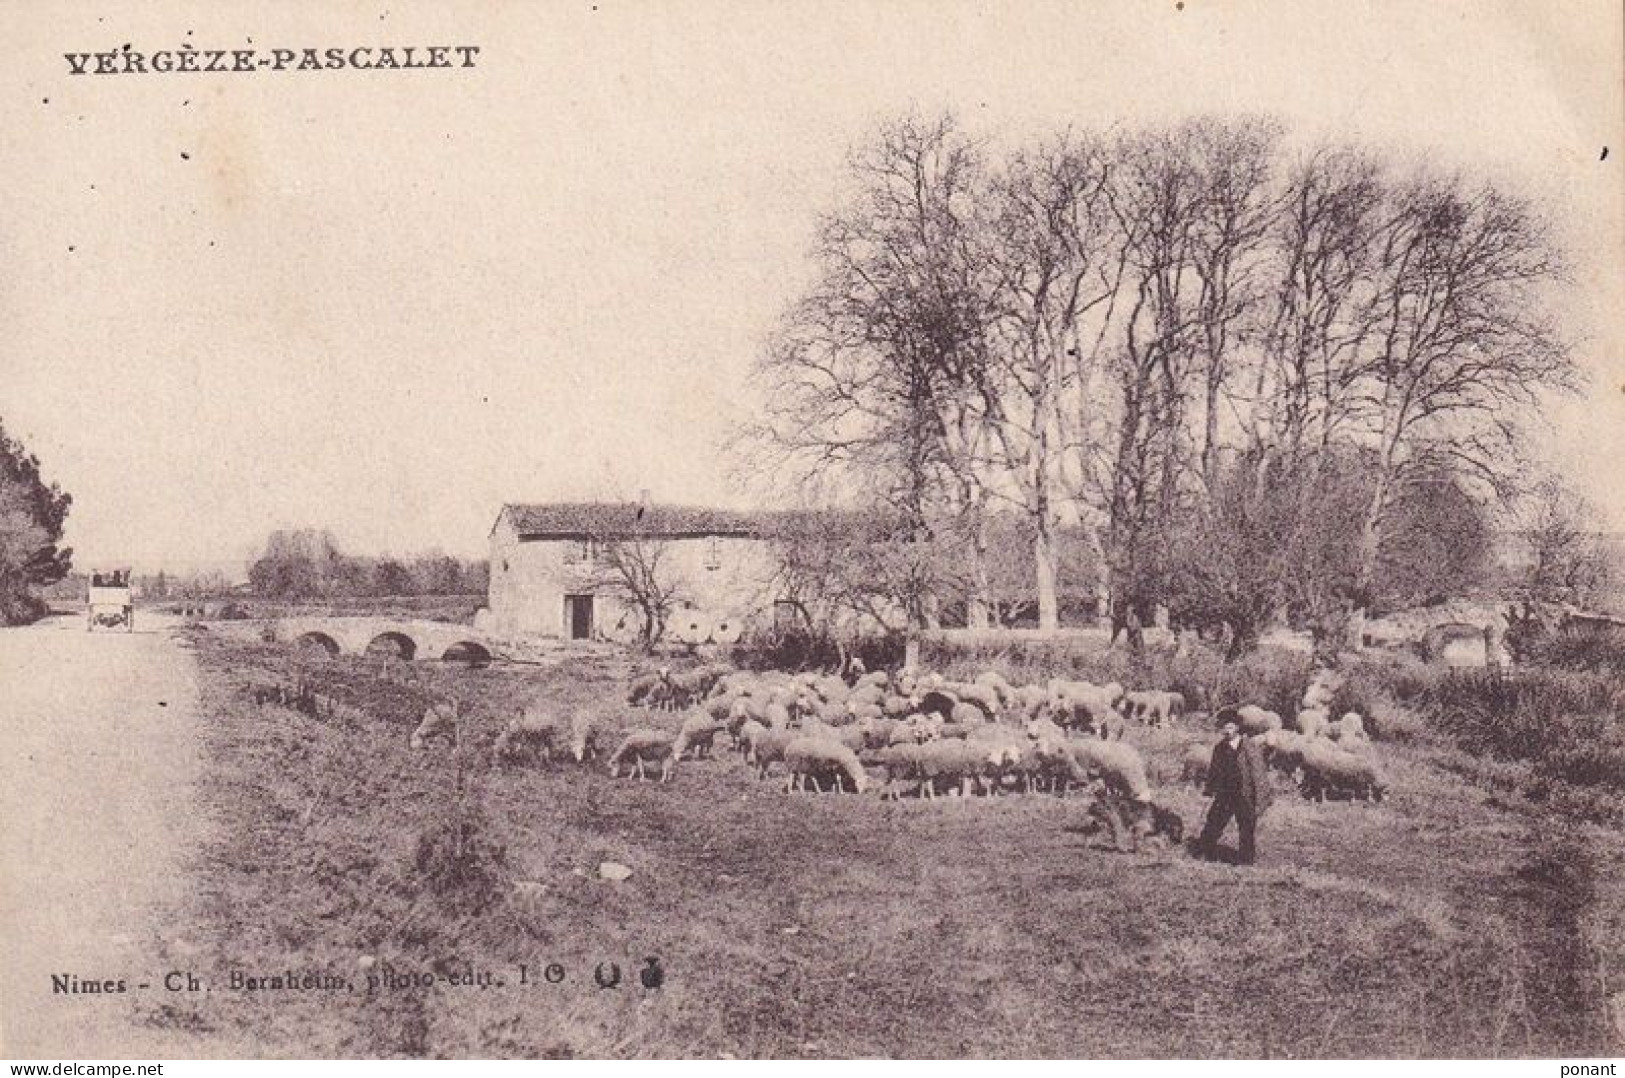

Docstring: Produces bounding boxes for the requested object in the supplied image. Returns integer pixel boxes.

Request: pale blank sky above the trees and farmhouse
[0,0,1625,567]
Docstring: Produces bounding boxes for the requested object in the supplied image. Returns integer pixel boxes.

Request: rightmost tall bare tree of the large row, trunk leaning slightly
[1355,177,1578,614]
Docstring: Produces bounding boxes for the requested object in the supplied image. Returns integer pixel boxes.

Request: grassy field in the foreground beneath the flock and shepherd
[150,634,1625,1057]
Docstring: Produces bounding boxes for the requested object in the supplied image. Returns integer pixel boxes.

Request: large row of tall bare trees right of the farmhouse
[741,117,1578,652]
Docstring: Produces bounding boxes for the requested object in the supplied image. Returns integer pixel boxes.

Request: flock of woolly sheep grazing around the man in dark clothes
[411,653,1386,845]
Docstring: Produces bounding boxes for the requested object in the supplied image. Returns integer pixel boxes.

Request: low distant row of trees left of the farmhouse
[249,528,489,600]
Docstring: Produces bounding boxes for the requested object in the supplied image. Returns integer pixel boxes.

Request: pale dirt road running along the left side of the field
[0,618,234,1058]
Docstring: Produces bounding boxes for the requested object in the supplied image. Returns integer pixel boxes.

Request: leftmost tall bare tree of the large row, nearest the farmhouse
[744,117,986,656]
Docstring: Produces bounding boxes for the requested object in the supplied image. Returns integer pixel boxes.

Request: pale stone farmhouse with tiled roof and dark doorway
[481,502,777,644]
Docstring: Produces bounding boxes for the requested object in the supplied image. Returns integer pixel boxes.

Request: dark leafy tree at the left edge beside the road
[0,424,73,624]
